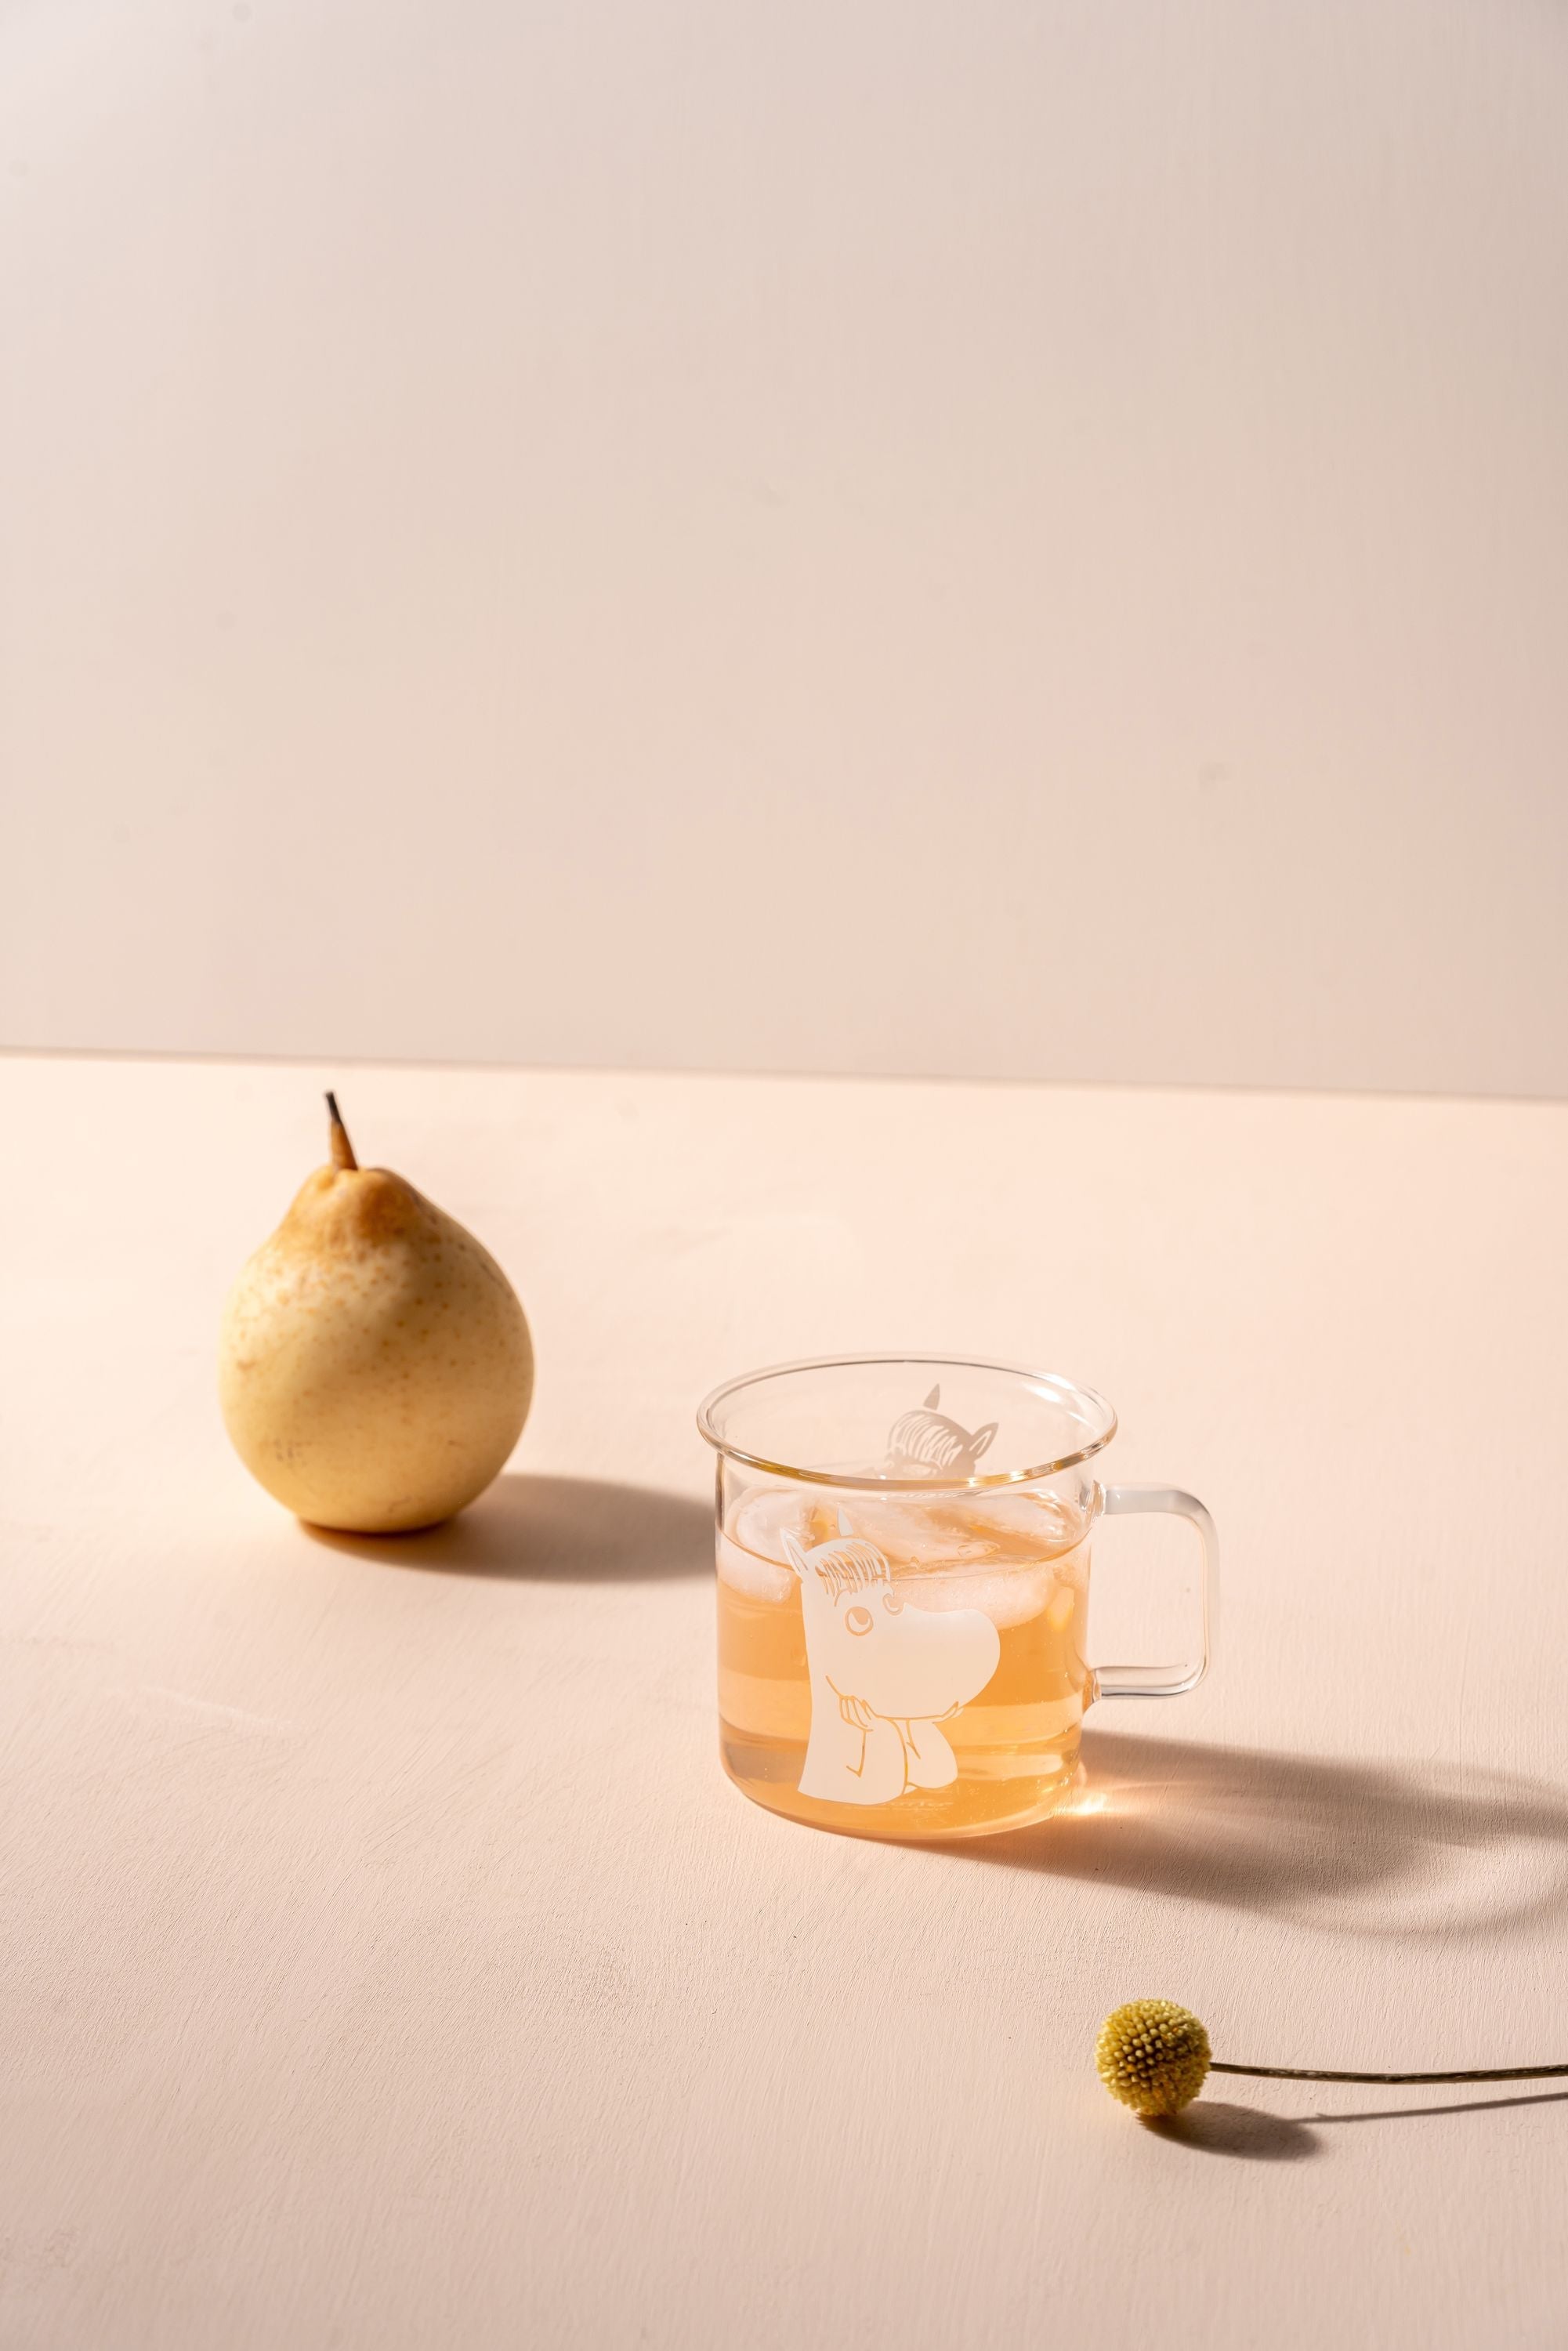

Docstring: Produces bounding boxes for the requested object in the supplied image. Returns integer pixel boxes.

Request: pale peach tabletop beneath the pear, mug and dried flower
[0,1058,1568,2351]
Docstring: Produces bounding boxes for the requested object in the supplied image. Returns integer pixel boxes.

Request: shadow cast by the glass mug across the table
[964,1730,1568,1937]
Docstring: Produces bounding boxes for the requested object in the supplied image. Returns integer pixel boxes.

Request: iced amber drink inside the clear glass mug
[719,1491,1088,1838]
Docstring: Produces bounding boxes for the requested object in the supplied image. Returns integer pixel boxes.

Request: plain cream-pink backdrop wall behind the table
[0,0,1568,1093]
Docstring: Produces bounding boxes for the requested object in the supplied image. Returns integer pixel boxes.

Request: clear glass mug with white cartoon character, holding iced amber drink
[698,1354,1218,1838]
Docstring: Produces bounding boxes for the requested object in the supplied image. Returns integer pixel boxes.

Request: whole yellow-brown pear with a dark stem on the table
[219,1096,534,1535]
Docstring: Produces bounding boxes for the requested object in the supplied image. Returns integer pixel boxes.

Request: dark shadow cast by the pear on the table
[306,1472,712,1585]
